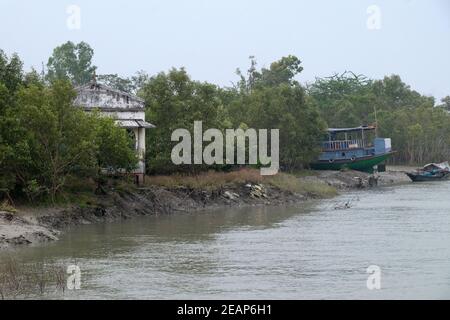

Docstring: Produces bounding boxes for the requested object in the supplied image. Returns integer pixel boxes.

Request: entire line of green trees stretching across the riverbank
[0,42,450,199]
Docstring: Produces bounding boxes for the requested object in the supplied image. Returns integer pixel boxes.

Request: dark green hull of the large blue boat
[311,152,392,172]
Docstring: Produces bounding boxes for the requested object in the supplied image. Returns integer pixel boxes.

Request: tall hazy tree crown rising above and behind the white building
[47,41,97,85]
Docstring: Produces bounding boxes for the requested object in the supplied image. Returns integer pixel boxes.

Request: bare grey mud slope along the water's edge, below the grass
[0,169,408,249]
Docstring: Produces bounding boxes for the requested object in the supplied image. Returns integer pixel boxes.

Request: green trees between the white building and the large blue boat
[143,56,326,173]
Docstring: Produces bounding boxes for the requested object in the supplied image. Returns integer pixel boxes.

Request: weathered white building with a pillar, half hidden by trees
[74,78,155,184]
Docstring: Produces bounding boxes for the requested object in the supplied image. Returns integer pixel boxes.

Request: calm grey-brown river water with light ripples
[2,182,450,299]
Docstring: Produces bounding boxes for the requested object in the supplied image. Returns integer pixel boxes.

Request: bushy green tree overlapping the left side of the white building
[10,80,137,202]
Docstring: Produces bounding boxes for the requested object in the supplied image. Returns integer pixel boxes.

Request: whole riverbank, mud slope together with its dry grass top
[0,167,409,249]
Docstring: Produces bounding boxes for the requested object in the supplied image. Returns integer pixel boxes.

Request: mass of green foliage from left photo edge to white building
[0,51,137,201]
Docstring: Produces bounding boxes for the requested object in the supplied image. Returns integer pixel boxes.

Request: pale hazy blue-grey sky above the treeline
[0,0,450,99]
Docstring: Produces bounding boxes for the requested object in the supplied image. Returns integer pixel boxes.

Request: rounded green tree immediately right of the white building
[142,69,227,172]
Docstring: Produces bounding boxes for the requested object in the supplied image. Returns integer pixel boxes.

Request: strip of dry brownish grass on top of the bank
[146,168,337,197]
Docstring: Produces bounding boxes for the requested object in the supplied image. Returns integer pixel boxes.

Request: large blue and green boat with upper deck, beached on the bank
[310,125,394,173]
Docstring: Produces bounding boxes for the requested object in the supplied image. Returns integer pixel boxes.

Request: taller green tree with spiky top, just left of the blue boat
[227,56,326,169]
